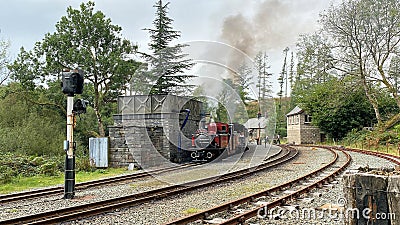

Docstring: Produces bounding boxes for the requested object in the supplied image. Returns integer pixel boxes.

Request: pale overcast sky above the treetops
[0,0,330,95]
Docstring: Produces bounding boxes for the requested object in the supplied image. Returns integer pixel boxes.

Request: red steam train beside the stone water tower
[185,118,248,161]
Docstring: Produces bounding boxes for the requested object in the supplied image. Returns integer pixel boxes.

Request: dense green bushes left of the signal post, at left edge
[0,84,65,155]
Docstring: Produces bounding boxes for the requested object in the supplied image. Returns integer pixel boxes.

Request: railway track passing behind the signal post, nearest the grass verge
[0,163,201,204]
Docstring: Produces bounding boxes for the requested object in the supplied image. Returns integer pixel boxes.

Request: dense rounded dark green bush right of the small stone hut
[298,78,375,139]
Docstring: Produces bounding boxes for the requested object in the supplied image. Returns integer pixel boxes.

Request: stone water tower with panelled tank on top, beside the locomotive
[109,95,202,168]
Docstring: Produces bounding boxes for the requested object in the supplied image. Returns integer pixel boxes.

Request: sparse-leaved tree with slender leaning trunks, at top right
[321,0,400,129]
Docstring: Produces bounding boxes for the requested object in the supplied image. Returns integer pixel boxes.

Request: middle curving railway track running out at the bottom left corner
[0,147,298,224]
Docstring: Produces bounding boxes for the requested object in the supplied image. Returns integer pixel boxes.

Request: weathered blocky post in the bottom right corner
[343,172,400,225]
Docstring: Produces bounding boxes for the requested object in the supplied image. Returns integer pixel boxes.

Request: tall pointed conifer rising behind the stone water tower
[141,0,194,94]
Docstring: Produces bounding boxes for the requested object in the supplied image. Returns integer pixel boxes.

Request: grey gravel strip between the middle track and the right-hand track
[66,148,333,224]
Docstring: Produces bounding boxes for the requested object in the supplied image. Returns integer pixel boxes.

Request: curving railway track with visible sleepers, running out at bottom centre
[165,147,351,225]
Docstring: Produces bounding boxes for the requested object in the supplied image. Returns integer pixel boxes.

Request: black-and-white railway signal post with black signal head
[61,70,83,199]
